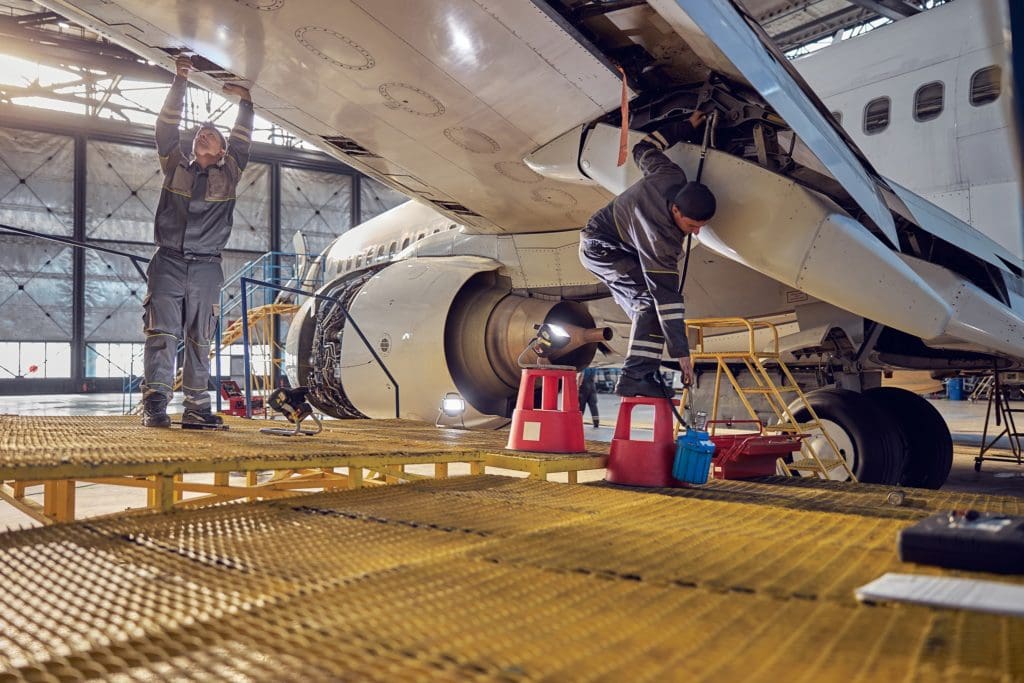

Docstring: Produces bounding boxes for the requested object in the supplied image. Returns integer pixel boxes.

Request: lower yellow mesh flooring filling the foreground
[0,476,1024,682]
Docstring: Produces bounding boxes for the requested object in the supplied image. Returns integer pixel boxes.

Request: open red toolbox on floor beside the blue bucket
[708,420,806,479]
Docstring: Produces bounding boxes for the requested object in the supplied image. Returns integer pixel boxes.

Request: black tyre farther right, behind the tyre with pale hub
[864,387,953,488]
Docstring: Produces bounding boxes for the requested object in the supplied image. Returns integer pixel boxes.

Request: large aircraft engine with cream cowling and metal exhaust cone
[286,256,611,427]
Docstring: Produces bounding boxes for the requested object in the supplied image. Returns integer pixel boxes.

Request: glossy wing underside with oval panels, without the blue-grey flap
[39,0,622,232]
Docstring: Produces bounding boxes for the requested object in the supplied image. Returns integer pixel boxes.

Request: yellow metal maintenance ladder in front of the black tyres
[684,317,857,481]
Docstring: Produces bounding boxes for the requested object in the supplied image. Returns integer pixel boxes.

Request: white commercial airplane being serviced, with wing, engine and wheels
[37,0,1024,487]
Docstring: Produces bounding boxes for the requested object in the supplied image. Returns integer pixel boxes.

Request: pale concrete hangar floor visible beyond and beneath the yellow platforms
[0,393,1024,528]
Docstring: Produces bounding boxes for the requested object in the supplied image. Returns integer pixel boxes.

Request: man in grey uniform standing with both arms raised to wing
[142,55,253,427]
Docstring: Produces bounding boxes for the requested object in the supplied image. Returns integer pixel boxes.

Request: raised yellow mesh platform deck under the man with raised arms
[0,415,607,479]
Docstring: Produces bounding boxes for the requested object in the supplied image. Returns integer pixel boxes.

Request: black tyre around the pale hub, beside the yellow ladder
[794,389,903,484]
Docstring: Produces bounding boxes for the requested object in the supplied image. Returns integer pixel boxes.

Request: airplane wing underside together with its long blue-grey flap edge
[32,0,1007,270]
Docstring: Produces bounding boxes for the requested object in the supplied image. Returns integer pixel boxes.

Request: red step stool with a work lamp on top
[505,367,587,453]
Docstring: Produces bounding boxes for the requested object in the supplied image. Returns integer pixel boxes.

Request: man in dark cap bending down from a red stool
[580,110,716,397]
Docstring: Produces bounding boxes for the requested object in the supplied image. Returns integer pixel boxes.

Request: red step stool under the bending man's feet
[604,396,686,487]
